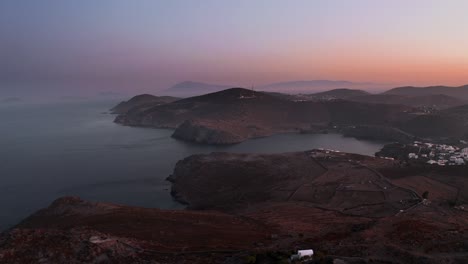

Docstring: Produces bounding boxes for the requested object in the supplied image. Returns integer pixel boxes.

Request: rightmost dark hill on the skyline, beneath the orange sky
[384,85,468,100]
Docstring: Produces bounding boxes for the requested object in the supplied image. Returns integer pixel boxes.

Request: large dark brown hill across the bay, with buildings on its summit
[115,88,411,144]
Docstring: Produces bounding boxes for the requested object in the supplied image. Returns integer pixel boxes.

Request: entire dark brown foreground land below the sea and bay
[0,150,468,264]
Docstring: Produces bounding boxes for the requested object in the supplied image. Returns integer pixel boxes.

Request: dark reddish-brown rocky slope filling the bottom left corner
[0,197,276,264]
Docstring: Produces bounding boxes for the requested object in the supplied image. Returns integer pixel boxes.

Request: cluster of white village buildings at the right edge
[408,141,468,166]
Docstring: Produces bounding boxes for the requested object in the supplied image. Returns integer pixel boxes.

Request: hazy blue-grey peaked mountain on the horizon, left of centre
[164,81,234,97]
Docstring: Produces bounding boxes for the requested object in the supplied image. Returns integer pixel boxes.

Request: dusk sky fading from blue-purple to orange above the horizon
[0,0,468,97]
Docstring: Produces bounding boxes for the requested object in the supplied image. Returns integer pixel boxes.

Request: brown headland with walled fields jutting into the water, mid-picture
[169,152,419,217]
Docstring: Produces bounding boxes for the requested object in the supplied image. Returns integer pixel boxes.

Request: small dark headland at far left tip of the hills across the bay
[110,94,180,114]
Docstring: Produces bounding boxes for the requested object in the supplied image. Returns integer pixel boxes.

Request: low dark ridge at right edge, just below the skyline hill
[347,93,468,109]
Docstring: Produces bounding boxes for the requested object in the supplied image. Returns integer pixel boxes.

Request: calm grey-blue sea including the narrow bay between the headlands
[0,102,383,230]
